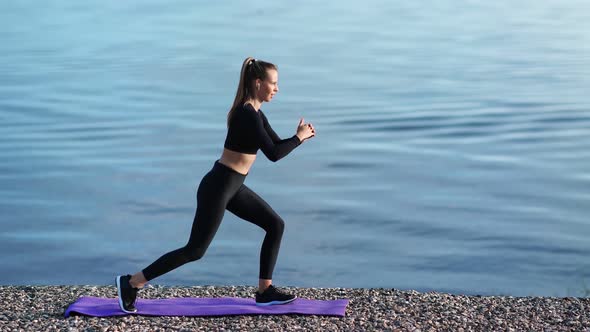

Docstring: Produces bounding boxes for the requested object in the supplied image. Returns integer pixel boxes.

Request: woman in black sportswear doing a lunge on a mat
[116,57,315,313]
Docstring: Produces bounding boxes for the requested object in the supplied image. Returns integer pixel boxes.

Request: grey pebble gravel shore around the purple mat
[0,286,590,331]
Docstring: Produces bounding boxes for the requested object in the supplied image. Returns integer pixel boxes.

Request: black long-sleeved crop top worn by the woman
[224,103,301,162]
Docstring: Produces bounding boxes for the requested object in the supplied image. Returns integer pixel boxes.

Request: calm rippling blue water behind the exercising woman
[0,0,590,296]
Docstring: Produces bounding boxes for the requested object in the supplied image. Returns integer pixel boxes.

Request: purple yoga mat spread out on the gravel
[65,296,349,317]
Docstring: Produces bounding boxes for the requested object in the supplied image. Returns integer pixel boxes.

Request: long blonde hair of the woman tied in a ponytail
[227,56,277,128]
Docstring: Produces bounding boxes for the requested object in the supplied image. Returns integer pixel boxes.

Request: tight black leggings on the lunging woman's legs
[142,160,285,281]
